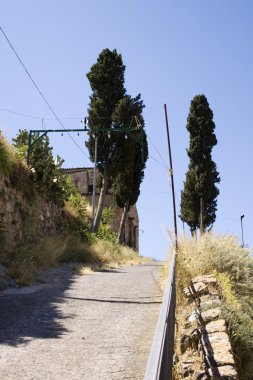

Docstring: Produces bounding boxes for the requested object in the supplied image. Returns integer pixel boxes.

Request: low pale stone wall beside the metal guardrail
[175,275,238,380]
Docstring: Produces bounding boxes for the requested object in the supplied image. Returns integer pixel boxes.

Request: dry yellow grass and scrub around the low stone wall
[177,233,253,380]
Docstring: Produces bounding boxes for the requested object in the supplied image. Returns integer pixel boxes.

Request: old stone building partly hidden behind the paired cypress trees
[62,168,139,251]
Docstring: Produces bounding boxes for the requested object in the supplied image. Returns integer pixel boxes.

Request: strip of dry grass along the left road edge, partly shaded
[7,235,144,285]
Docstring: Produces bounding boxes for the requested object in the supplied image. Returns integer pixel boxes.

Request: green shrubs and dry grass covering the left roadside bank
[0,131,141,285]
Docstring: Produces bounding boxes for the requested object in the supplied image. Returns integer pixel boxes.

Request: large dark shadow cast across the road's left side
[0,267,74,346]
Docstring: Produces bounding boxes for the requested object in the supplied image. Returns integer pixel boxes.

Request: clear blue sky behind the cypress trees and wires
[0,0,253,258]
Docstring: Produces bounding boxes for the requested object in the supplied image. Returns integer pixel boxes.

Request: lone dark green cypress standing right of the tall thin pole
[180,95,220,233]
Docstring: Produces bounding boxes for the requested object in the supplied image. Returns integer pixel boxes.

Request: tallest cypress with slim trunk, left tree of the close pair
[86,49,126,232]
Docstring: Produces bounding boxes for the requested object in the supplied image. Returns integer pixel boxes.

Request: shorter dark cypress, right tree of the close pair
[113,94,148,243]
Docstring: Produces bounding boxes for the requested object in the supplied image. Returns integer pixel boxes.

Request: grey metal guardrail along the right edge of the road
[144,253,176,380]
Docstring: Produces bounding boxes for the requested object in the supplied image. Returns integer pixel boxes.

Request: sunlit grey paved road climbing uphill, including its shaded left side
[0,262,162,380]
